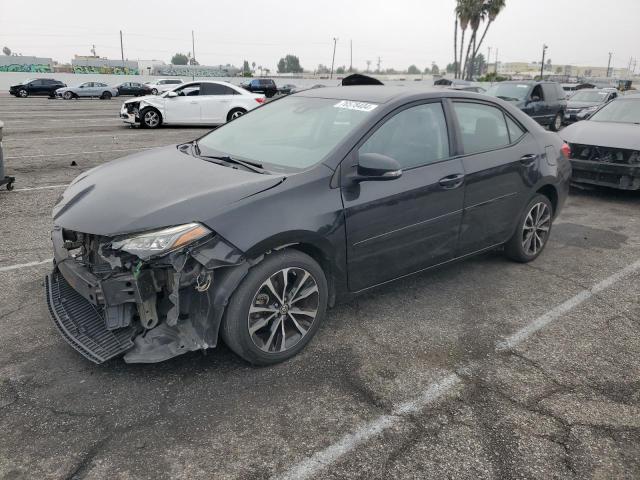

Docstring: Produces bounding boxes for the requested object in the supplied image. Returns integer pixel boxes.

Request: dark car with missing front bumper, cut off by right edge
[561,94,640,190]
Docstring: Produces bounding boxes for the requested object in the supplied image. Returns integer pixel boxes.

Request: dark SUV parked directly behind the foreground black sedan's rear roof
[486,81,567,132]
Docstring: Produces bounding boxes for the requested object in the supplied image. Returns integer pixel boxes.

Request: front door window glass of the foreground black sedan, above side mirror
[359,103,449,169]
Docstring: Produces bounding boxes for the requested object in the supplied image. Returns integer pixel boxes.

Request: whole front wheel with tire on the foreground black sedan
[220,249,328,365]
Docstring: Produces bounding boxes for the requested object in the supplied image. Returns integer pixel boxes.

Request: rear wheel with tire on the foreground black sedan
[505,194,553,263]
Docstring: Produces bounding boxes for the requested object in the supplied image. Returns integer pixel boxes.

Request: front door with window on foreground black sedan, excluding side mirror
[341,101,464,291]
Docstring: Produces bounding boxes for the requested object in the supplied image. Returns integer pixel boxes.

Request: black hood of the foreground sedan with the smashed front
[53,146,284,236]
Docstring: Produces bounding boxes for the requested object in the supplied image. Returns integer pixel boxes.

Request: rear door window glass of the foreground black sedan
[453,102,509,153]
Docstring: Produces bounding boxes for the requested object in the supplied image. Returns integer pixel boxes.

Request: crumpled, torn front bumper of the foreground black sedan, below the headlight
[45,227,249,363]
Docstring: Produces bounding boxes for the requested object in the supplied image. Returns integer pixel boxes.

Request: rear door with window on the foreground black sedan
[453,100,542,256]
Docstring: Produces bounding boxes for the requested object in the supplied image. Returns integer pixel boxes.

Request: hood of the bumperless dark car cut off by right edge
[560,120,640,150]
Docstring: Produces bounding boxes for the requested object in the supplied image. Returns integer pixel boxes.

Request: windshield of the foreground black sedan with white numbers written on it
[198,97,377,170]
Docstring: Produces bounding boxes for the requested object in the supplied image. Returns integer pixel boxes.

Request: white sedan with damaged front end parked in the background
[120,81,265,128]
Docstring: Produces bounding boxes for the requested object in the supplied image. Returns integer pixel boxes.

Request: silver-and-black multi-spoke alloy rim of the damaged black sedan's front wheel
[247,267,320,353]
